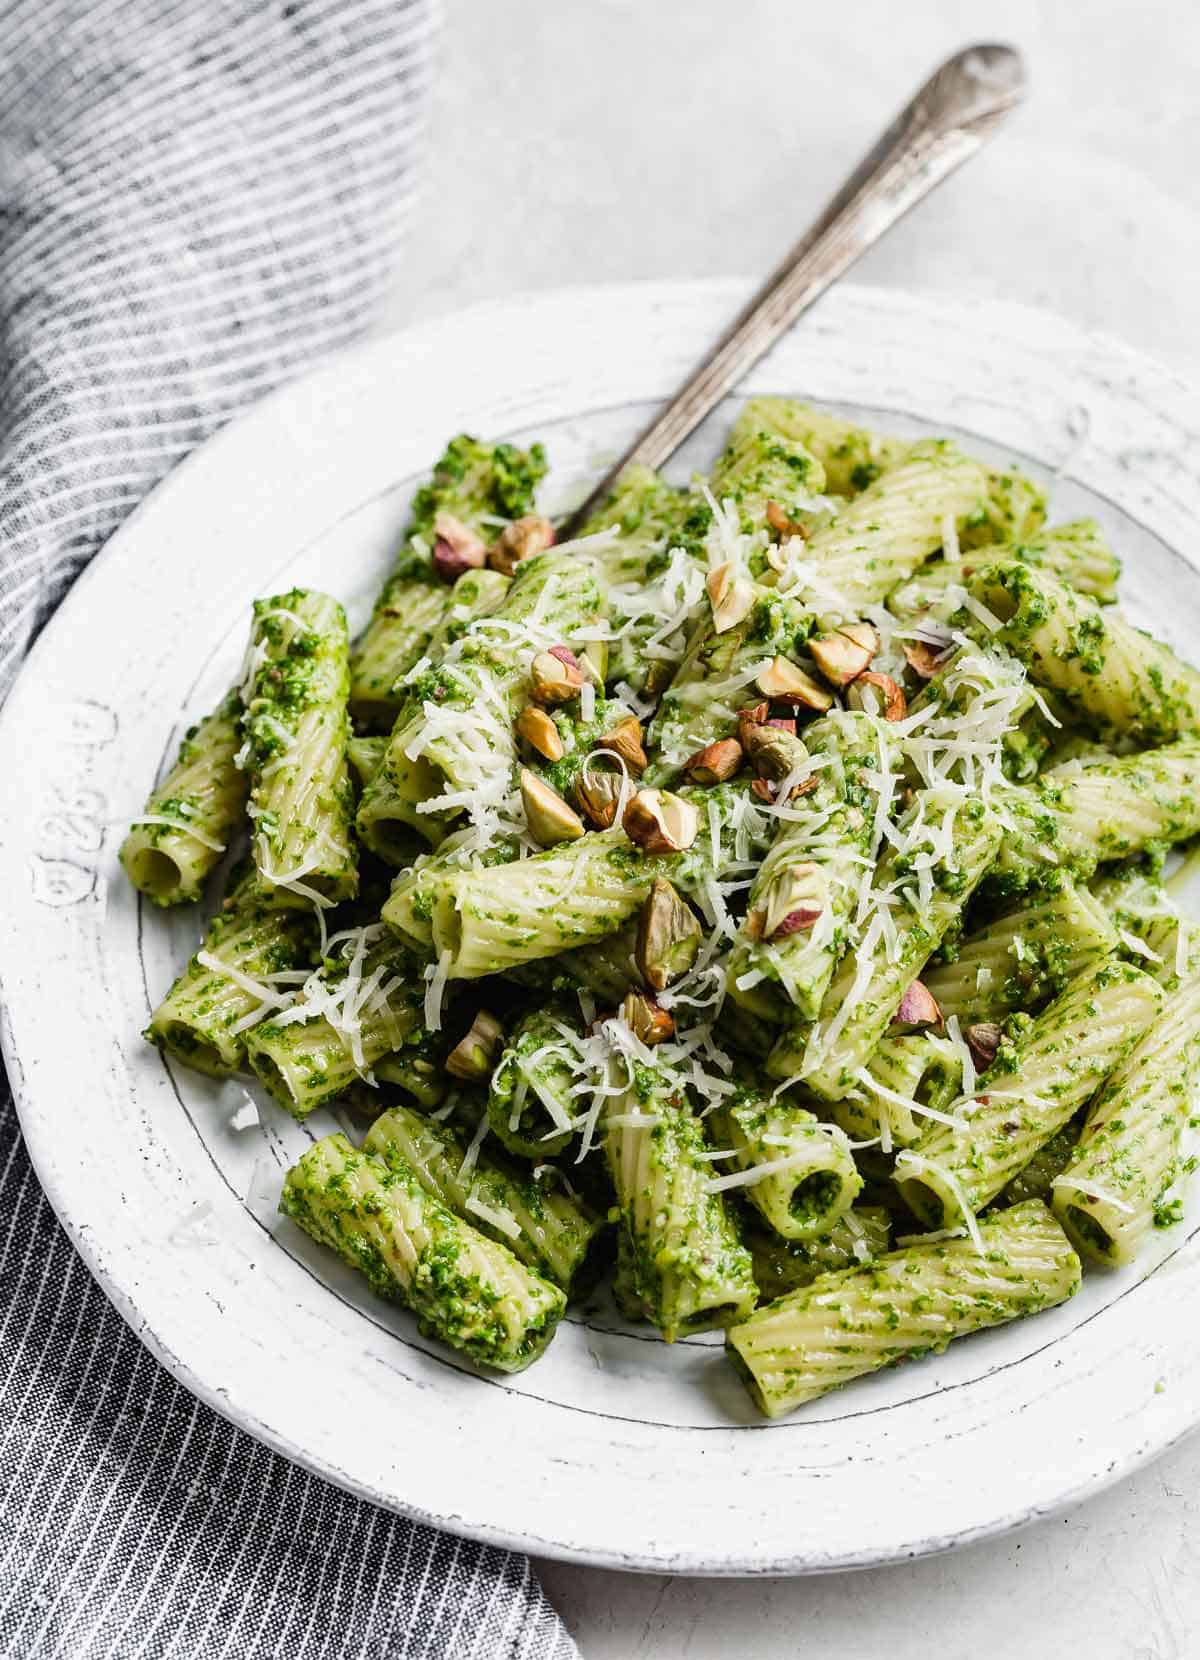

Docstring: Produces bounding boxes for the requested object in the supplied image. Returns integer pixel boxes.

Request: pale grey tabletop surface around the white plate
[387,0,1200,1660]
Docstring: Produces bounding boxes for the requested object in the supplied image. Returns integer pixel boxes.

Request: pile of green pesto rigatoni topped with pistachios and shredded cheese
[121,397,1200,1416]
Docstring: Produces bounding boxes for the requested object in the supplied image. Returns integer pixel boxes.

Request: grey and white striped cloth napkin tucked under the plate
[0,0,576,1660]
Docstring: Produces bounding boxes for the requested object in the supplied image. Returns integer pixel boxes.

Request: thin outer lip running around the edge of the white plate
[0,277,1200,1577]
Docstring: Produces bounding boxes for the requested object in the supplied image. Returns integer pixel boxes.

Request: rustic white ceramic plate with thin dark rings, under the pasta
[0,284,1200,1574]
